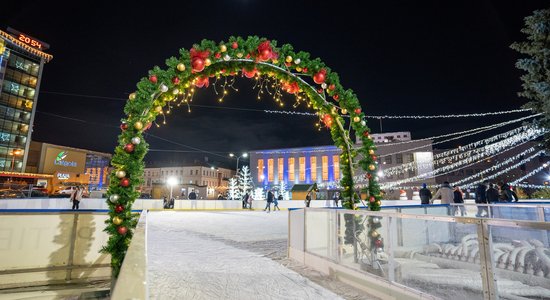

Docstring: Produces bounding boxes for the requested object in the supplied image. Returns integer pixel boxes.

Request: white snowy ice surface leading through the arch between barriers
[147,211,352,299]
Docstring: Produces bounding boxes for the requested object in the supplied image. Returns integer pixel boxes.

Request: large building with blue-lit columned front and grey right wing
[250,132,435,197]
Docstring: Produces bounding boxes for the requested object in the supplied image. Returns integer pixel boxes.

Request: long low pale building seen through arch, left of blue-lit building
[141,164,235,199]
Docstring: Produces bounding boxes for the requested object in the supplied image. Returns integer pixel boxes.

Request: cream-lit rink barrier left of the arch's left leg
[0,212,111,289]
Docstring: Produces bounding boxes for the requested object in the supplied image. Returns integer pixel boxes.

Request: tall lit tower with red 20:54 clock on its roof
[0,28,52,172]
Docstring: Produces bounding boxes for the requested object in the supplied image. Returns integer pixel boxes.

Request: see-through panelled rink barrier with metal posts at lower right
[289,208,550,299]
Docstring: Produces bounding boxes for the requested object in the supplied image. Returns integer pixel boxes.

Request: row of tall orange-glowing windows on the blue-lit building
[258,155,340,182]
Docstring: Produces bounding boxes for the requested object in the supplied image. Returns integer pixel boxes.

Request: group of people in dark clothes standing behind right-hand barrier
[419,181,518,217]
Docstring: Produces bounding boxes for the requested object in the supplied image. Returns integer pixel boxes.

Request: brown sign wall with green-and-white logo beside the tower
[42,147,86,174]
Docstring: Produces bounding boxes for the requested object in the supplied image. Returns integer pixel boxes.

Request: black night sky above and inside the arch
[0,0,548,166]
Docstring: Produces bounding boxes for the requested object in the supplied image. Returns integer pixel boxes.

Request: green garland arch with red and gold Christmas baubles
[103,36,386,277]
